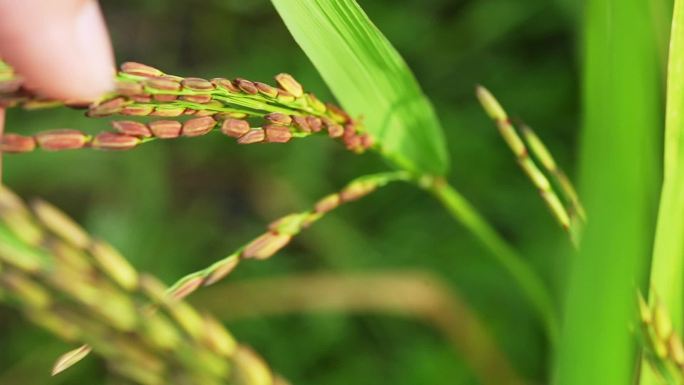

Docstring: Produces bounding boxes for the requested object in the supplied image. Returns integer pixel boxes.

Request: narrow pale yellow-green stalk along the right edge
[641,0,684,384]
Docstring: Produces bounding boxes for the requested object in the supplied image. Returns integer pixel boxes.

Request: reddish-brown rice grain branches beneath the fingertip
[0,62,375,153]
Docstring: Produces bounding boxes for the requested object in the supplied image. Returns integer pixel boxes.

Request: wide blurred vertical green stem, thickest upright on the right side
[555,0,660,385]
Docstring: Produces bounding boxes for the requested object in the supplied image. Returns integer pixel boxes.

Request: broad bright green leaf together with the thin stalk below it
[272,0,559,341]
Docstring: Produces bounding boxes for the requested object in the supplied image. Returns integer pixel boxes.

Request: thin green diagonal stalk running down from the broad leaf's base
[427,179,558,343]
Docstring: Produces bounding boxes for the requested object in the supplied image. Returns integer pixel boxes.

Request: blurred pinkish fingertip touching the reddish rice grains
[0,0,114,100]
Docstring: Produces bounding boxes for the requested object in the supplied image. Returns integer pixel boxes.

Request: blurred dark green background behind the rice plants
[0,0,580,385]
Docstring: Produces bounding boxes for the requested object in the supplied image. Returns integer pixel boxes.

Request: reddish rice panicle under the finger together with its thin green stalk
[0,62,557,340]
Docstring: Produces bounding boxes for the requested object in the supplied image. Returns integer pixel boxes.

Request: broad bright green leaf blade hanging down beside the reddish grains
[272,0,448,174]
